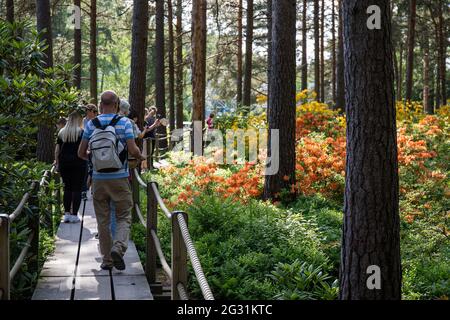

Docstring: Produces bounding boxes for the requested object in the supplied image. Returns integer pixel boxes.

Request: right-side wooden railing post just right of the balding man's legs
[145,182,158,283]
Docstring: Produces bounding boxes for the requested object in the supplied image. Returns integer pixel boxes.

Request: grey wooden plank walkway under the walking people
[32,198,153,300]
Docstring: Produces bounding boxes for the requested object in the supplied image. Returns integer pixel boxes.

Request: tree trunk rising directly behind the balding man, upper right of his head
[129,0,149,128]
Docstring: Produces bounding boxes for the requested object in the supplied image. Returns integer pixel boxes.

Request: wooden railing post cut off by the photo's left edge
[0,214,10,300]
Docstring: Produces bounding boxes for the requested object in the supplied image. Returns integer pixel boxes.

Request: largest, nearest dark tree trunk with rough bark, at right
[339,0,401,300]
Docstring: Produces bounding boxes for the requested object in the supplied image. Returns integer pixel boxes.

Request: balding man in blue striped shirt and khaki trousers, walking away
[78,91,145,270]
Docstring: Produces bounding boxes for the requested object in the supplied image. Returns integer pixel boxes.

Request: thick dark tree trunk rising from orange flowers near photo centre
[264,0,296,199]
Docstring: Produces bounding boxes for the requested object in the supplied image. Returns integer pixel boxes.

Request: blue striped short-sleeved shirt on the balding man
[83,113,134,180]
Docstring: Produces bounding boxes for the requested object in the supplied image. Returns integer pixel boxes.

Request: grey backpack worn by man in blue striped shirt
[89,115,127,172]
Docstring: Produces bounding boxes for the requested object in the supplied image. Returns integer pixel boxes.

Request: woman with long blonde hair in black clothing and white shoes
[55,112,87,222]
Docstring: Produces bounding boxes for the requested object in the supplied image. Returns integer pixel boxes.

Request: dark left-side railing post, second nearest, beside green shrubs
[28,181,40,273]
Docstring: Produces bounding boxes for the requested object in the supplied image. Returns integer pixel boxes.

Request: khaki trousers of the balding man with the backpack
[92,178,133,263]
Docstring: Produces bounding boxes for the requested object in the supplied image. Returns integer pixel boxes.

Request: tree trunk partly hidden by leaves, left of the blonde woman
[36,0,55,163]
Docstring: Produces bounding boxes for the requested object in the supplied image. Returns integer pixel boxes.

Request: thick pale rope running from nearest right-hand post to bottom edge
[177,214,214,300]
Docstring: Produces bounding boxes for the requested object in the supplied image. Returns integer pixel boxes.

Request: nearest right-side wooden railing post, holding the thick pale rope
[171,211,187,300]
